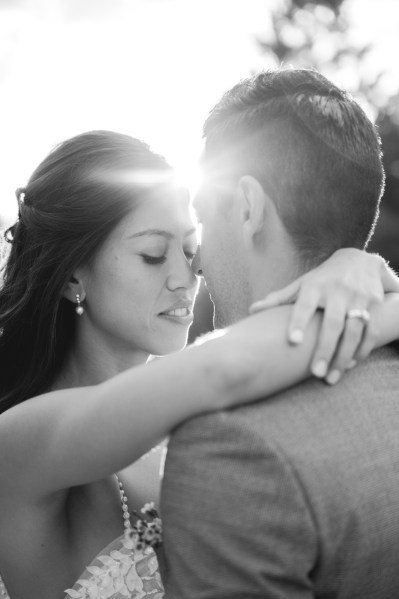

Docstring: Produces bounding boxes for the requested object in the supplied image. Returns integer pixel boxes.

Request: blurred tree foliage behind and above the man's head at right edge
[257,0,399,271]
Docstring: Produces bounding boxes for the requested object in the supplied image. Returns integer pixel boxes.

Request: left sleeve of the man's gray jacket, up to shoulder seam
[161,406,316,599]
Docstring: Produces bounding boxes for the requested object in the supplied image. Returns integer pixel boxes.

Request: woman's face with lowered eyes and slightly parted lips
[80,188,198,355]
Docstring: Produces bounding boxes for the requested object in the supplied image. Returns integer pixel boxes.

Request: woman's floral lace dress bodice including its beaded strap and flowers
[0,479,164,599]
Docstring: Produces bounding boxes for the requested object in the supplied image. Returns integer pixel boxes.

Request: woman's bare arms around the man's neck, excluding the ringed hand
[0,296,399,499]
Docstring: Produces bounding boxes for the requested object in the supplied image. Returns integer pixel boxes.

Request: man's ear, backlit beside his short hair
[238,175,267,249]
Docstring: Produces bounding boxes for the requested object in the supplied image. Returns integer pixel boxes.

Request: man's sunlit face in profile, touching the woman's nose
[194,181,251,327]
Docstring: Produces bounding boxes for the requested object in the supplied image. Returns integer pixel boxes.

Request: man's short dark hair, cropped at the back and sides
[204,69,384,264]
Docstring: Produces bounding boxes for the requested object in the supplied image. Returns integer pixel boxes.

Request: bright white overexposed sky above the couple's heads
[0,0,399,222]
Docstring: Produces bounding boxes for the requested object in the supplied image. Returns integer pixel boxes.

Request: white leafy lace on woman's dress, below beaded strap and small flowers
[65,536,164,599]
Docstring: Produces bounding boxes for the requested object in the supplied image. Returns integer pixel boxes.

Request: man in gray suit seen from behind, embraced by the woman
[161,70,399,599]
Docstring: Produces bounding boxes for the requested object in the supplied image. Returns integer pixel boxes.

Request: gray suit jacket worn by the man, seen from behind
[161,347,399,599]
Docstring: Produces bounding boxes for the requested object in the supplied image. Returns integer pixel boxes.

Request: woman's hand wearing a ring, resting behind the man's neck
[250,248,399,384]
